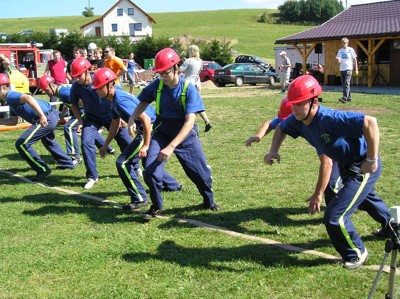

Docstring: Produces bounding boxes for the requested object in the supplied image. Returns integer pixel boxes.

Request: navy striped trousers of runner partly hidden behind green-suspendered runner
[116,134,181,202]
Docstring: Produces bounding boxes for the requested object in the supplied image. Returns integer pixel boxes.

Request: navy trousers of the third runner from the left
[82,117,132,180]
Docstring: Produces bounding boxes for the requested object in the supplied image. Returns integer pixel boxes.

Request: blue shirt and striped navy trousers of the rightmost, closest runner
[280,106,390,261]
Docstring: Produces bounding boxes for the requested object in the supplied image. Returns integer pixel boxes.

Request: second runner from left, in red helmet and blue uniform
[39,75,115,165]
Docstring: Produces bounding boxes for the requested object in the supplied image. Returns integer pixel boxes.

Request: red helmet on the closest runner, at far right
[287,75,322,104]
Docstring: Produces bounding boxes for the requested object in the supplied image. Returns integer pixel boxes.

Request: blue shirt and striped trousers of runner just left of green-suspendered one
[111,89,181,203]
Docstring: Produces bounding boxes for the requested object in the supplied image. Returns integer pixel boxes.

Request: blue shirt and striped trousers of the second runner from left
[56,84,112,160]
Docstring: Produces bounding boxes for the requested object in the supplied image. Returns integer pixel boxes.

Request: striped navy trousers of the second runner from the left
[64,116,112,159]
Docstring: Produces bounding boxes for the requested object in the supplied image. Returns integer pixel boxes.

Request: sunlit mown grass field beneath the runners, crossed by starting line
[0,87,400,298]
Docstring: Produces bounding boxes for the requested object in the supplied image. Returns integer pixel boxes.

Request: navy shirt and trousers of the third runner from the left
[70,81,132,180]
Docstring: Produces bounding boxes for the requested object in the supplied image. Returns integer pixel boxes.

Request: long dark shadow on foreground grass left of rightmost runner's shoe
[122,240,332,273]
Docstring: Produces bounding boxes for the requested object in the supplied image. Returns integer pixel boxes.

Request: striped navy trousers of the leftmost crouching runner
[15,108,74,174]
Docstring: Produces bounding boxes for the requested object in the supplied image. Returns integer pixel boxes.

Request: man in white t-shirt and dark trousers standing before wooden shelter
[336,37,358,103]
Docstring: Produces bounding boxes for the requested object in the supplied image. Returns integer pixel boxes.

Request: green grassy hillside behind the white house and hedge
[0,9,311,62]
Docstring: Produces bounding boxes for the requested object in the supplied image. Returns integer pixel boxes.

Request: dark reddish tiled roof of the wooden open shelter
[275,0,400,44]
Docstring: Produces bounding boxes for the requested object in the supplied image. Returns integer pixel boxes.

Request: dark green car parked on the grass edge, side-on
[214,63,279,86]
